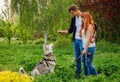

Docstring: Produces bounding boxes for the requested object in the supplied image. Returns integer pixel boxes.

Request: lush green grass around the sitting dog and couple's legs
[0,40,120,82]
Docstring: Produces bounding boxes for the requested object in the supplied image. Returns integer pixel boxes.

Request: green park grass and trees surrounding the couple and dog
[0,0,120,82]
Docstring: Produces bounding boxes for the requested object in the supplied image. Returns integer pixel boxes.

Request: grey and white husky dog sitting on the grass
[19,44,56,76]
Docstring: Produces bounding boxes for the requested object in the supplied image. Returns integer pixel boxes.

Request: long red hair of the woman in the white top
[81,12,95,34]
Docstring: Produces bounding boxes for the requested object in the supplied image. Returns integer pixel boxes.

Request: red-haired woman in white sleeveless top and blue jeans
[80,12,98,76]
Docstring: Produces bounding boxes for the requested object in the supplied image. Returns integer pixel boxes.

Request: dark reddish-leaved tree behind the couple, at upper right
[74,0,120,42]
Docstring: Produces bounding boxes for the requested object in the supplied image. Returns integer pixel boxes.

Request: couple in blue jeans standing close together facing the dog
[58,5,98,78]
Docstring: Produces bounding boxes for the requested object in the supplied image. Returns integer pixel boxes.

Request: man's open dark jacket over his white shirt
[68,16,76,41]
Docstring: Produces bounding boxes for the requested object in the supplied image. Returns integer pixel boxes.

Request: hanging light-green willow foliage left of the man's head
[8,0,73,43]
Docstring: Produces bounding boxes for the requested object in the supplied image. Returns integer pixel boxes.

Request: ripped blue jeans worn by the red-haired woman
[82,47,98,76]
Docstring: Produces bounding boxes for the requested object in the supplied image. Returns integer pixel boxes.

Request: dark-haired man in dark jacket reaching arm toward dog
[58,5,82,78]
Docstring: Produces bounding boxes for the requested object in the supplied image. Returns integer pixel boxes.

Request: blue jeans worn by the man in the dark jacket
[74,39,83,74]
